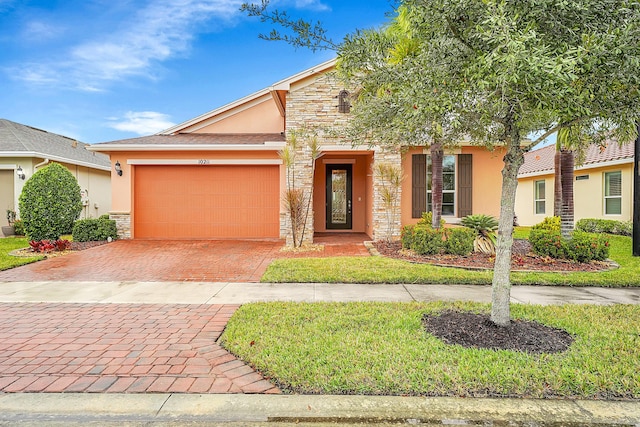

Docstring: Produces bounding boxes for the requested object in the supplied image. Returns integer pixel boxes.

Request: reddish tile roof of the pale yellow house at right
[518,141,634,178]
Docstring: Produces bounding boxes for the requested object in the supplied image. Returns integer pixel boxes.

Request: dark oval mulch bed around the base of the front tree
[422,311,573,354]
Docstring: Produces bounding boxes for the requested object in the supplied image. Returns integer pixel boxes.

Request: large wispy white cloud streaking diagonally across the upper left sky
[10,0,242,91]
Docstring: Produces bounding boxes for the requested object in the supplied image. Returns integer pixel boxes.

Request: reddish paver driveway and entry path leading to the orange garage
[0,235,369,282]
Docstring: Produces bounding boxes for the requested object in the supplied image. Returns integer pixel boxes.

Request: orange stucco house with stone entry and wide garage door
[89,60,504,240]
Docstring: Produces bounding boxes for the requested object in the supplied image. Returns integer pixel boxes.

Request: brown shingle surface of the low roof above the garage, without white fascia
[94,133,285,146]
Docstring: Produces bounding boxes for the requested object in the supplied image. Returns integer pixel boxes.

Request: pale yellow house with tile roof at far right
[516,142,634,225]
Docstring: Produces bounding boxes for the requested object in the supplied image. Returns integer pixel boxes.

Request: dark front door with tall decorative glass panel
[327,165,352,230]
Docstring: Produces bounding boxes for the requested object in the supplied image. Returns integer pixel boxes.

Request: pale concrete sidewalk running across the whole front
[0,282,640,305]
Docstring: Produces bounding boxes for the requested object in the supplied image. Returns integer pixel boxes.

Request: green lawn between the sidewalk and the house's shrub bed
[261,234,640,287]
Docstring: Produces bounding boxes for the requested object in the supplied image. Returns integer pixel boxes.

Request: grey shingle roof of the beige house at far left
[0,119,111,170]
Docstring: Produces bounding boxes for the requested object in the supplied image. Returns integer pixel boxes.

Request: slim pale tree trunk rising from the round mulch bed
[491,138,524,326]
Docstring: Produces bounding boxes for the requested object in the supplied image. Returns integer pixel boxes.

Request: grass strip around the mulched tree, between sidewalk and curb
[222,302,640,399]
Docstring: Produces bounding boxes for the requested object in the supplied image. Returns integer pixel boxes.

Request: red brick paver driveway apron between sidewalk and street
[0,303,279,393]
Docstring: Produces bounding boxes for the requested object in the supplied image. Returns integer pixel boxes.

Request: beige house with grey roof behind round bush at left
[0,119,111,225]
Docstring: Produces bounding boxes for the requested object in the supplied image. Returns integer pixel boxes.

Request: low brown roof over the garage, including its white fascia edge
[89,133,285,151]
